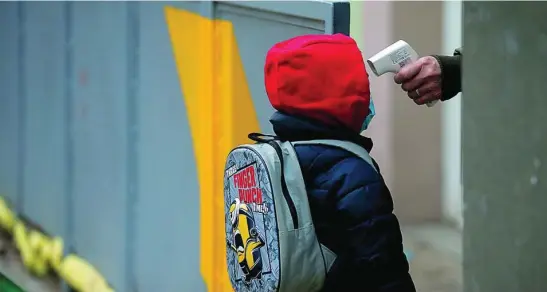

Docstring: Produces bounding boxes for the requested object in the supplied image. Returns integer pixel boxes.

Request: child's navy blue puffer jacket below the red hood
[270,112,416,292]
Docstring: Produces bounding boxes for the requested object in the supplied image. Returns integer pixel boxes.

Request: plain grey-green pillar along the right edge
[462,1,547,292]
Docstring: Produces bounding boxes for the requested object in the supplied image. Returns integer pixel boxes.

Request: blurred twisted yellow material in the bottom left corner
[0,197,114,292]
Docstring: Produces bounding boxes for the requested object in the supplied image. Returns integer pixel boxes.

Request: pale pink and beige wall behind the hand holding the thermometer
[352,1,443,223]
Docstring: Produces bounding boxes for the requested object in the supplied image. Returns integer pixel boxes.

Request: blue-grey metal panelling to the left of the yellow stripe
[0,2,203,291]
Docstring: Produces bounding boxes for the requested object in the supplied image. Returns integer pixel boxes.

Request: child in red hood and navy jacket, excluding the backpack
[264,34,415,292]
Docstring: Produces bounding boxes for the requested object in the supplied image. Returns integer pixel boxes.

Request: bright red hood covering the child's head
[264,34,370,132]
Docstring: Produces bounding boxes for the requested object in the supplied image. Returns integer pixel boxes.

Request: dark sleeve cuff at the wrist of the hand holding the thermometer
[433,48,462,101]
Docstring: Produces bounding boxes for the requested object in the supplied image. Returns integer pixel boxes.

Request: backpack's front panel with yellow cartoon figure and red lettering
[224,149,279,292]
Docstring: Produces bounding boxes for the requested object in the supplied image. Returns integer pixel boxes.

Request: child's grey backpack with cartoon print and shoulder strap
[224,133,376,292]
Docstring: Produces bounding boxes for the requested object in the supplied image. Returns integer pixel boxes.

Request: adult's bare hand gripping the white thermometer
[394,56,442,104]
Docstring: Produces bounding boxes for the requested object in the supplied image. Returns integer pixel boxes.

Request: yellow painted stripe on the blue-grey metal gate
[165,7,259,292]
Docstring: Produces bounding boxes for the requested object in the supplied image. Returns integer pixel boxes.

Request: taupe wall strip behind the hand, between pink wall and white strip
[392,1,443,222]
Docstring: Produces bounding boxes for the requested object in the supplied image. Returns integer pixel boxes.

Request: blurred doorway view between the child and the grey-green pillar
[351,1,463,292]
